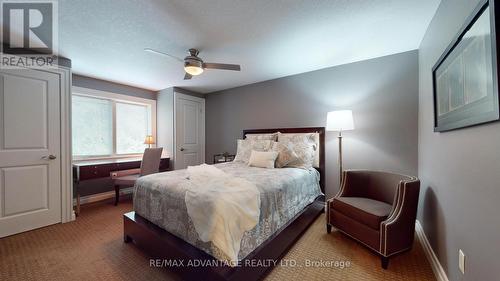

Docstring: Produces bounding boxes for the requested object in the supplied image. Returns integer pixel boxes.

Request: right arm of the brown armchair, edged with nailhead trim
[380,178,420,257]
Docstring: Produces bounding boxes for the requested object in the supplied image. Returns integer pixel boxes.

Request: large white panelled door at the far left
[0,70,61,237]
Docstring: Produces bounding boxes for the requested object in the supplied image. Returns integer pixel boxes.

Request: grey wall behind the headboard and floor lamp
[206,51,418,196]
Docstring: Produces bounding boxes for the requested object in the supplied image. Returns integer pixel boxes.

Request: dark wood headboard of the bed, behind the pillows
[243,127,325,193]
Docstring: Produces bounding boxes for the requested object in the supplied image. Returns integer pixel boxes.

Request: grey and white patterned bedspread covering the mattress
[134,162,322,260]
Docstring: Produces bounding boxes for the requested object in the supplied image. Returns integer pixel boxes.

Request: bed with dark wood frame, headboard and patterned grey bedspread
[124,127,324,280]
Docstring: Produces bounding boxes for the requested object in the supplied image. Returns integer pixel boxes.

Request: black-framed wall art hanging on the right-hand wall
[432,0,500,132]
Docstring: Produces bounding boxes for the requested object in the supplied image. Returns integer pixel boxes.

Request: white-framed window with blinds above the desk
[72,87,156,159]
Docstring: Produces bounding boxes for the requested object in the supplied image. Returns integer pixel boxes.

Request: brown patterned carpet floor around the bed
[0,198,435,281]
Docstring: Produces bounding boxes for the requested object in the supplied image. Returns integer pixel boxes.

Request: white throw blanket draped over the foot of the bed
[183,164,260,265]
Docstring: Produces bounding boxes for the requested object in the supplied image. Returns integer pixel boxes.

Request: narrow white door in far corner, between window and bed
[174,93,205,170]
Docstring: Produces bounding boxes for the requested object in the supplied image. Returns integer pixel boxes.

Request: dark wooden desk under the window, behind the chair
[73,158,170,215]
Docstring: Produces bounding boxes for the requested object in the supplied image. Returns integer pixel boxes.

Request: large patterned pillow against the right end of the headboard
[278,133,316,169]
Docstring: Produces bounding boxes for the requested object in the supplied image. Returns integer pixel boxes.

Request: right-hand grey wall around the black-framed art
[418,0,500,280]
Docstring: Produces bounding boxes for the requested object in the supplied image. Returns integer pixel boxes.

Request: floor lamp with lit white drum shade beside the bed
[326,110,354,184]
